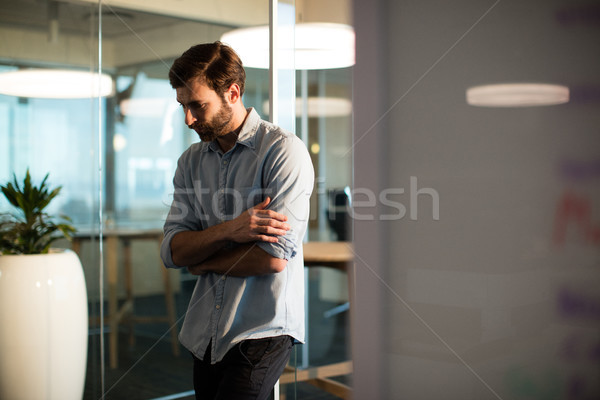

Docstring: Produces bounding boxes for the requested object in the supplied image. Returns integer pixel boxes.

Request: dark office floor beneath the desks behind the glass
[84,276,350,400]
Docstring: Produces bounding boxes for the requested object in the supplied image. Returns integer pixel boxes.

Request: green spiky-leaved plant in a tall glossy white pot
[0,170,88,400]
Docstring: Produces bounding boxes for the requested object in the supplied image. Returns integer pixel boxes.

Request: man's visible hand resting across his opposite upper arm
[227,197,290,243]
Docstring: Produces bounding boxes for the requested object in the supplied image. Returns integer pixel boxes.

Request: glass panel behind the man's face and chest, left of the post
[94,1,268,398]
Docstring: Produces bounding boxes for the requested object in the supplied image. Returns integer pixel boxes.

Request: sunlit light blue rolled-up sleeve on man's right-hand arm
[257,135,314,260]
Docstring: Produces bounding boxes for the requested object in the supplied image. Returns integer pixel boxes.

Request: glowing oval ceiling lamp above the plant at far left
[0,69,114,99]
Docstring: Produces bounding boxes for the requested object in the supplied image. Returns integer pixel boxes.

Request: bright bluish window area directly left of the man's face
[109,71,192,227]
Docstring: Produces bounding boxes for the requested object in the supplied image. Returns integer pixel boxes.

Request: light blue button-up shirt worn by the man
[161,108,314,363]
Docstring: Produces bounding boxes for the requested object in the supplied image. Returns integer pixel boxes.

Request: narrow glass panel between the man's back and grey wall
[288,3,352,398]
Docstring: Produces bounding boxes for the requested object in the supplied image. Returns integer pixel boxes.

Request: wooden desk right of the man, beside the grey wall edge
[279,242,354,399]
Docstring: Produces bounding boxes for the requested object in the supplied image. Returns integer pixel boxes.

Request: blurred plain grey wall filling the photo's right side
[352,0,600,400]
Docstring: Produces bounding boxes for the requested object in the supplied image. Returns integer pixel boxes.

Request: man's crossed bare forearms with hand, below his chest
[171,197,290,276]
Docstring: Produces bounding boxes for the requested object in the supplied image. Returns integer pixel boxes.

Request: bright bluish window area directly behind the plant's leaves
[0,68,103,226]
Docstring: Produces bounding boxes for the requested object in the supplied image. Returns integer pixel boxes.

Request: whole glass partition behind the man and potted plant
[0,0,351,399]
